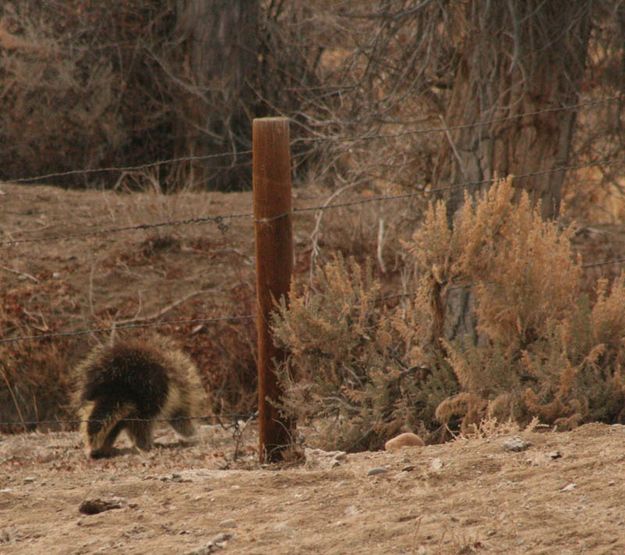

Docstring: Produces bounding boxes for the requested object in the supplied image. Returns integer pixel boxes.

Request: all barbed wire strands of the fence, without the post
[0,95,625,440]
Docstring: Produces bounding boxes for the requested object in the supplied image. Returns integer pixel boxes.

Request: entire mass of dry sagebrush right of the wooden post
[274,179,625,450]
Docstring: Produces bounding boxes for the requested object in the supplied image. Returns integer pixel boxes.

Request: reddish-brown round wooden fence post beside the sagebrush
[252,118,293,462]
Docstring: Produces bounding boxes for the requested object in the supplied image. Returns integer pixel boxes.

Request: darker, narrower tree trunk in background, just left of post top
[177,0,260,191]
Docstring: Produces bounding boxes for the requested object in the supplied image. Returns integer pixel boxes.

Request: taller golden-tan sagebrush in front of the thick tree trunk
[408,179,625,431]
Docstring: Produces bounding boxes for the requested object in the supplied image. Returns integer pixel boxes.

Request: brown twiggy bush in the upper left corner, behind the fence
[0,3,129,185]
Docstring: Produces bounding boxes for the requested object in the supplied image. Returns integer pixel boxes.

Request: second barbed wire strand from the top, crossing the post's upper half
[0,154,624,246]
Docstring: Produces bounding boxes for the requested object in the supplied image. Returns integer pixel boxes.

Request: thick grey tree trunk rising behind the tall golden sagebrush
[434,0,591,343]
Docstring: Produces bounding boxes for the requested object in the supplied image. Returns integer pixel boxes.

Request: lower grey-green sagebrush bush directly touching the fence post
[273,256,453,451]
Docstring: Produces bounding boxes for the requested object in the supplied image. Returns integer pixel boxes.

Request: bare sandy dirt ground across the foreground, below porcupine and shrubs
[0,424,625,555]
